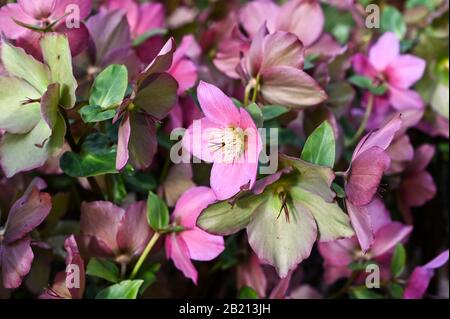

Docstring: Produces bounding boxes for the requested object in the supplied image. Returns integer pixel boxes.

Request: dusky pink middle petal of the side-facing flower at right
[345,146,391,206]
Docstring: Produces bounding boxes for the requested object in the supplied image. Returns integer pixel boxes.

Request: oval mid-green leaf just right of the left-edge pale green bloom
[89,64,128,109]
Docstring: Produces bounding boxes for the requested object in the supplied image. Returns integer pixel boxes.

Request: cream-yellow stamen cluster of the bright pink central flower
[208,127,245,164]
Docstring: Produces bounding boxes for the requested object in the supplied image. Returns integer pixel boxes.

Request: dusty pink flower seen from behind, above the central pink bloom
[238,25,327,108]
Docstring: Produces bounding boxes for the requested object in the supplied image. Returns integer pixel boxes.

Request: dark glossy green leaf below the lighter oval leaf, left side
[60,133,117,177]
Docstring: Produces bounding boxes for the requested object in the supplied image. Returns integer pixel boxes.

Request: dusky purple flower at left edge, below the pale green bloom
[0,184,52,289]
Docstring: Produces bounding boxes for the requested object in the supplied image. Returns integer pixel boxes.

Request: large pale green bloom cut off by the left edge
[0,34,77,177]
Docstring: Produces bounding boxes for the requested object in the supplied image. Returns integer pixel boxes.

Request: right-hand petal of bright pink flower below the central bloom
[180,227,225,261]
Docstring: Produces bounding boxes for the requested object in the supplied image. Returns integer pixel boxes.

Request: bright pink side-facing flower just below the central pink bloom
[165,187,225,284]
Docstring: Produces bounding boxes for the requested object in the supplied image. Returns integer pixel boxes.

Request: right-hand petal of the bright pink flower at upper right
[386,54,426,89]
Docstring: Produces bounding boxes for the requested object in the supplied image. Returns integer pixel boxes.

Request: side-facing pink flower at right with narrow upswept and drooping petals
[345,115,402,252]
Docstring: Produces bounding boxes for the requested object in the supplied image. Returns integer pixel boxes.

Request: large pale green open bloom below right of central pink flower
[197,155,354,278]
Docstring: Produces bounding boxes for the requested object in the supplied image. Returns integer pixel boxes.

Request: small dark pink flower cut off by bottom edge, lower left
[39,235,86,299]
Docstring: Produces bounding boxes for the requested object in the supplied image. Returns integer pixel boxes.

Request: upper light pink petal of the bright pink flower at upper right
[369,32,400,72]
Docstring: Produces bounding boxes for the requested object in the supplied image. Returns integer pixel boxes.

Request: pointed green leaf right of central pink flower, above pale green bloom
[301,121,336,167]
